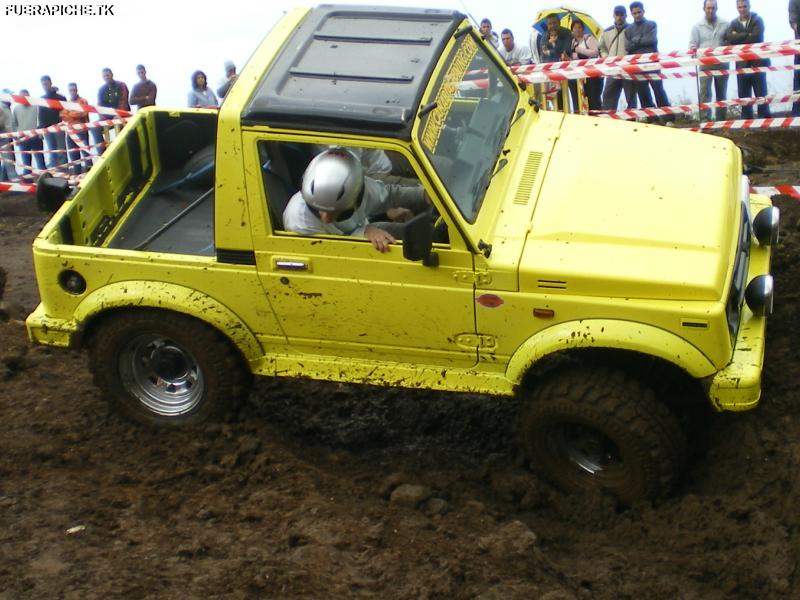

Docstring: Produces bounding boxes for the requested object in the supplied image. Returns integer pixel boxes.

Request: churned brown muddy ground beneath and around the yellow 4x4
[0,132,800,600]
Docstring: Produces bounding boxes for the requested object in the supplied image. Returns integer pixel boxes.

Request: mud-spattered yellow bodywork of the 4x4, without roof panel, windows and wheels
[28,9,769,410]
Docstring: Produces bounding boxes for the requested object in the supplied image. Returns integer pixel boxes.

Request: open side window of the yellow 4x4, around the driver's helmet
[258,140,444,247]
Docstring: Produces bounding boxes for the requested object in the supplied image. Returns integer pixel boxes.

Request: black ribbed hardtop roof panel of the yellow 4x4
[242,5,464,139]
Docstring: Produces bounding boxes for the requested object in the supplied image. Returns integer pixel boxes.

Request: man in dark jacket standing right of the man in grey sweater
[725,0,771,119]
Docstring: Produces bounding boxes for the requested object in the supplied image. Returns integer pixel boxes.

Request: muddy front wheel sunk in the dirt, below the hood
[520,367,687,504]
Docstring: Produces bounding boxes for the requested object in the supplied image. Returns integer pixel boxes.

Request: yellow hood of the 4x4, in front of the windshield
[519,116,741,300]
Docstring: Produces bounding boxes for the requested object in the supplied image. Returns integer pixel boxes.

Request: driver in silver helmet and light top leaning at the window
[283,147,426,252]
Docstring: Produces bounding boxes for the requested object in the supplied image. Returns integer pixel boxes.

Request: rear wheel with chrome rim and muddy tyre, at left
[89,310,249,427]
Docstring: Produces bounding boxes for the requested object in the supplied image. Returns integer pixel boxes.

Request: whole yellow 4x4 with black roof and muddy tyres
[27,6,778,501]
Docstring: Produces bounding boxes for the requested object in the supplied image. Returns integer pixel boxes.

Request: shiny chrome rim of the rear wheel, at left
[118,334,205,417]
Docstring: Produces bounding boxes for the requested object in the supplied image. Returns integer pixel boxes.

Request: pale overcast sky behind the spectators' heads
[0,0,793,106]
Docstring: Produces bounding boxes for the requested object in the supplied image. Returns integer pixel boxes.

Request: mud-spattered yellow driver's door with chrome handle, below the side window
[248,137,477,367]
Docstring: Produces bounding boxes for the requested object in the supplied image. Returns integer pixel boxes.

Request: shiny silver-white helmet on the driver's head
[302,148,364,213]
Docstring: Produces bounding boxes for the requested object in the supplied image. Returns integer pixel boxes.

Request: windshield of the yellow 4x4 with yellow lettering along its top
[419,34,519,223]
